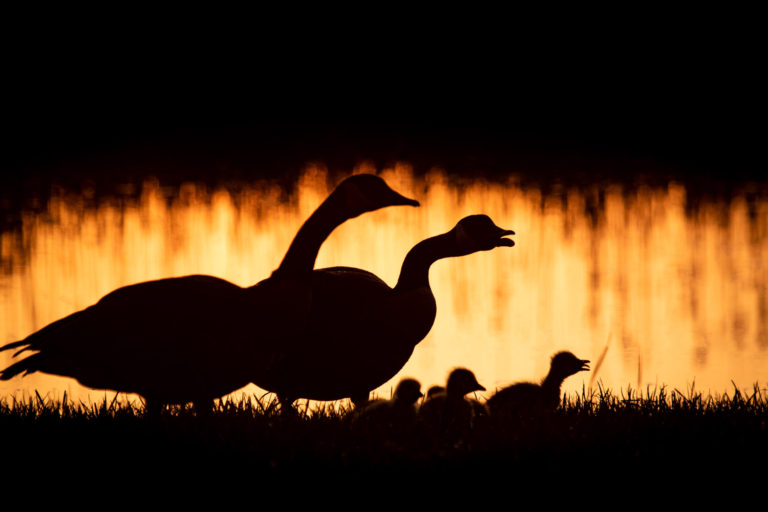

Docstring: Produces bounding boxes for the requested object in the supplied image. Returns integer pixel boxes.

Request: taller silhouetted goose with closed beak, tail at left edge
[0,175,419,414]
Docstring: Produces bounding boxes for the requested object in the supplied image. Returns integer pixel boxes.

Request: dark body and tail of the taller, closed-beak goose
[2,275,308,402]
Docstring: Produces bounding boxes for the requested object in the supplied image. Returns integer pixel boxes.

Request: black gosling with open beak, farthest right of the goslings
[486,351,589,416]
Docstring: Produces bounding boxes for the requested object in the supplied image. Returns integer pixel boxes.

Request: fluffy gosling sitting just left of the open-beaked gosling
[419,368,485,434]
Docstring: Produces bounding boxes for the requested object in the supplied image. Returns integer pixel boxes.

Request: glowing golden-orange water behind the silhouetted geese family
[0,166,768,400]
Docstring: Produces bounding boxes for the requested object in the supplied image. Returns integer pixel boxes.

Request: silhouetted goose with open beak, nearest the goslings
[253,215,514,404]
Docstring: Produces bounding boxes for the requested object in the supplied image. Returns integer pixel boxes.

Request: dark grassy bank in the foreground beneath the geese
[0,386,768,494]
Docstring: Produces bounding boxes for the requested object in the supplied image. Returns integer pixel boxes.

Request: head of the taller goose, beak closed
[333,174,419,218]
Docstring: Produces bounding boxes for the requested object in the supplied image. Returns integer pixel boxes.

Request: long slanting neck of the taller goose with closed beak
[272,196,349,277]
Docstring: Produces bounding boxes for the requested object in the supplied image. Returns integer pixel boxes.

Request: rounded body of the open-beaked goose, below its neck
[253,267,436,403]
